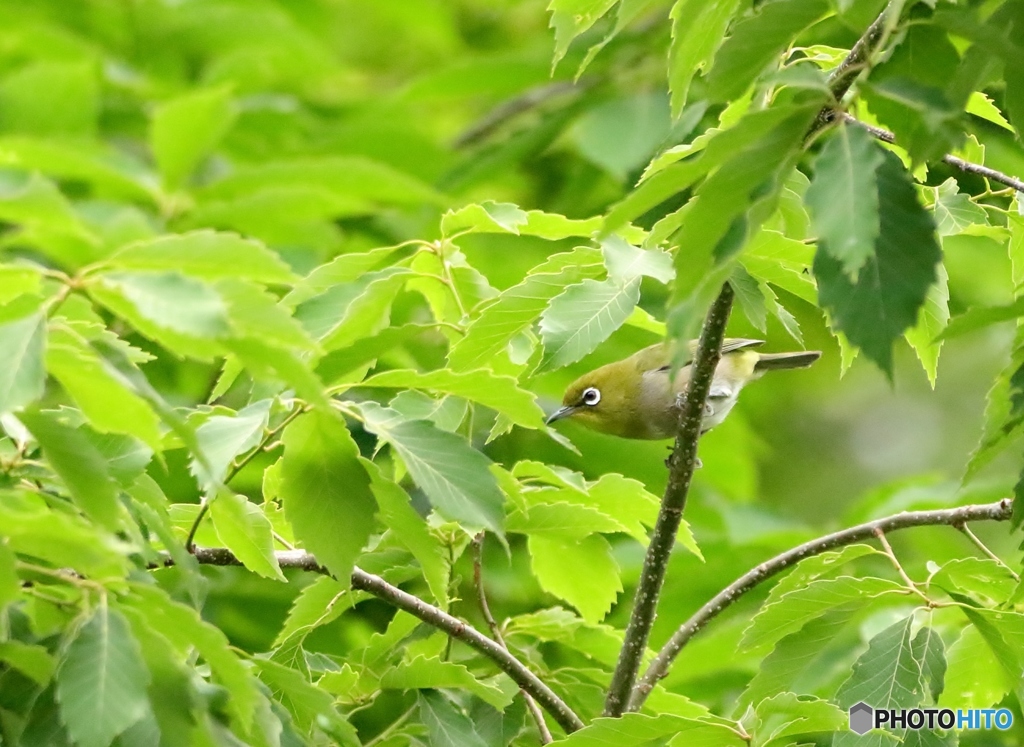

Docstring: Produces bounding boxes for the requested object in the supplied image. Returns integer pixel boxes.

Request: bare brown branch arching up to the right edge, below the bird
[630,498,1013,711]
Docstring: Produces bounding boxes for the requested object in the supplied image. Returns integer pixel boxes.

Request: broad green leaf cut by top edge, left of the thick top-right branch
[708,0,829,101]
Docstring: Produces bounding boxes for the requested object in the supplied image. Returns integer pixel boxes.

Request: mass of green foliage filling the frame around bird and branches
[0,0,1024,747]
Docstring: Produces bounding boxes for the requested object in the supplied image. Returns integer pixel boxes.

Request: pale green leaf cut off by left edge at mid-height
[0,314,46,413]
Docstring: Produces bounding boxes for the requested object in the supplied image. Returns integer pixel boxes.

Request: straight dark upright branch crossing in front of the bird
[604,283,733,716]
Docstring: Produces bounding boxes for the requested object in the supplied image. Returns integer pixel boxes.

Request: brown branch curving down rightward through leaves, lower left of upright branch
[176,547,585,734]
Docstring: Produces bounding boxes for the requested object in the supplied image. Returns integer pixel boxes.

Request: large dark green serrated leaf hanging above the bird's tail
[814,153,942,377]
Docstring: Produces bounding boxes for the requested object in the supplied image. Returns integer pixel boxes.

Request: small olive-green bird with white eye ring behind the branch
[548,338,821,439]
